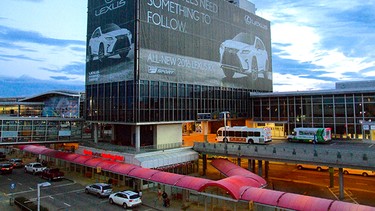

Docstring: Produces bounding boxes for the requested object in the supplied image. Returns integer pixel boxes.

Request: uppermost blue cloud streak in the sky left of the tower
[0,25,86,47]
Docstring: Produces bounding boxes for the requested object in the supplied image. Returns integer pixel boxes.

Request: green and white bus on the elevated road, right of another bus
[288,127,332,143]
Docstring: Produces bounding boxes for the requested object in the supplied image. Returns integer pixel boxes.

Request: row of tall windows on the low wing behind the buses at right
[252,93,375,138]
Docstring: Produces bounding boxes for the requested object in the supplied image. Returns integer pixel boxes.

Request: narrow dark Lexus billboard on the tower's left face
[86,0,136,85]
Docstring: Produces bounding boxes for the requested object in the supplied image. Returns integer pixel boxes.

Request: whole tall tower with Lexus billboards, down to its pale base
[85,0,272,149]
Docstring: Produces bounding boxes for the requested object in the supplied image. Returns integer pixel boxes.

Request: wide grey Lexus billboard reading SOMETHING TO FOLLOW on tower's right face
[139,0,272,91]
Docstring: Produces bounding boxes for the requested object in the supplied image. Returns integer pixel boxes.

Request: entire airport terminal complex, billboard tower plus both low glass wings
[0,0,375,151]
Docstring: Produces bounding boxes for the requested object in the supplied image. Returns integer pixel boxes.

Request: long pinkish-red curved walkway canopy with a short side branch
[19,145,375,211]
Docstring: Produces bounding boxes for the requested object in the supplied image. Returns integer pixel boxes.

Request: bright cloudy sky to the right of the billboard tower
[253,0,375,90]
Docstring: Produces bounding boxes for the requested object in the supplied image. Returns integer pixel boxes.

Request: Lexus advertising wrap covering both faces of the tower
[86,0,272,91]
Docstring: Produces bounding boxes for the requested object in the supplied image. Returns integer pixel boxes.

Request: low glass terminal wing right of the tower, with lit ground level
[251,86,375,139]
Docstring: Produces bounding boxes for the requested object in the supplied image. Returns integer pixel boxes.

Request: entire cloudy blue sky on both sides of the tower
[0,0,375,97]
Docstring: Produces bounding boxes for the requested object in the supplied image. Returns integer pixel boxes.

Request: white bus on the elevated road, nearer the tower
[216,126,272,144]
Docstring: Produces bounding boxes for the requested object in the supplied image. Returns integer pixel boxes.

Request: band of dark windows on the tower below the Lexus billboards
[86,80,251,122]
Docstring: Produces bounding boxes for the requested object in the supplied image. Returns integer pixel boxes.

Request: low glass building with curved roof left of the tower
[0,90,84,143]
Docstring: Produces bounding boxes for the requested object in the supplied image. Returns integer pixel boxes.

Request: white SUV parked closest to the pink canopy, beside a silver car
[109,191,142,209]
